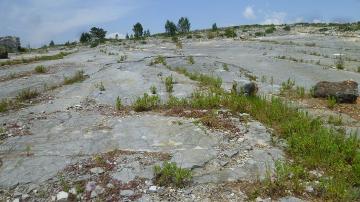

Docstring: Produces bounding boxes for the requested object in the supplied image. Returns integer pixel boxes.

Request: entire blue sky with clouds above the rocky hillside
[0,0,360,46]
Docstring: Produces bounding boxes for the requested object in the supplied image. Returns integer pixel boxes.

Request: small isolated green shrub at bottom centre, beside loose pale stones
[154,162,192,188]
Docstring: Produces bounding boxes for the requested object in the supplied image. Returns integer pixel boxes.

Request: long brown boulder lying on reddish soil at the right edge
[314,81,359,103]
